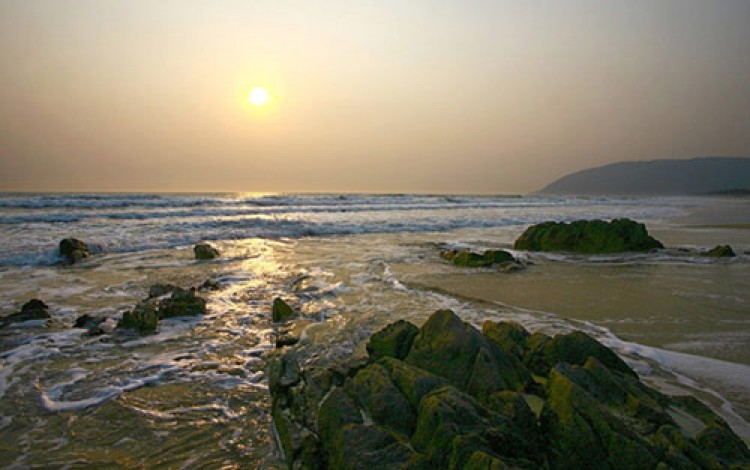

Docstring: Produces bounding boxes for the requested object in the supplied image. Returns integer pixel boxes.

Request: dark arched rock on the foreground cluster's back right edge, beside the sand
[524,331,637,377]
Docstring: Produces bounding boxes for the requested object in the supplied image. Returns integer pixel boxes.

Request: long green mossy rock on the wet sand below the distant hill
[514,219,664,254]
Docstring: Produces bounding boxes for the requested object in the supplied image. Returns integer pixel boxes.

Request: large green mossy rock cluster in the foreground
[268,310,750,470]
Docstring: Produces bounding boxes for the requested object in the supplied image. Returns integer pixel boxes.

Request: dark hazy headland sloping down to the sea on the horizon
[539,157,750,195]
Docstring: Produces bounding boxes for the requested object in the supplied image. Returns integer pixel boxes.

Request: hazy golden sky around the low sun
[0,0,750,193]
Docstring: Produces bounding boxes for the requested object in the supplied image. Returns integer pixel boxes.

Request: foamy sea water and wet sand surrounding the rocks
[0,194,750,468]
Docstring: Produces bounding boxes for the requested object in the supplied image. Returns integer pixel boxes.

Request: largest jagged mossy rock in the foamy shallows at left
[117,284,206,333]
